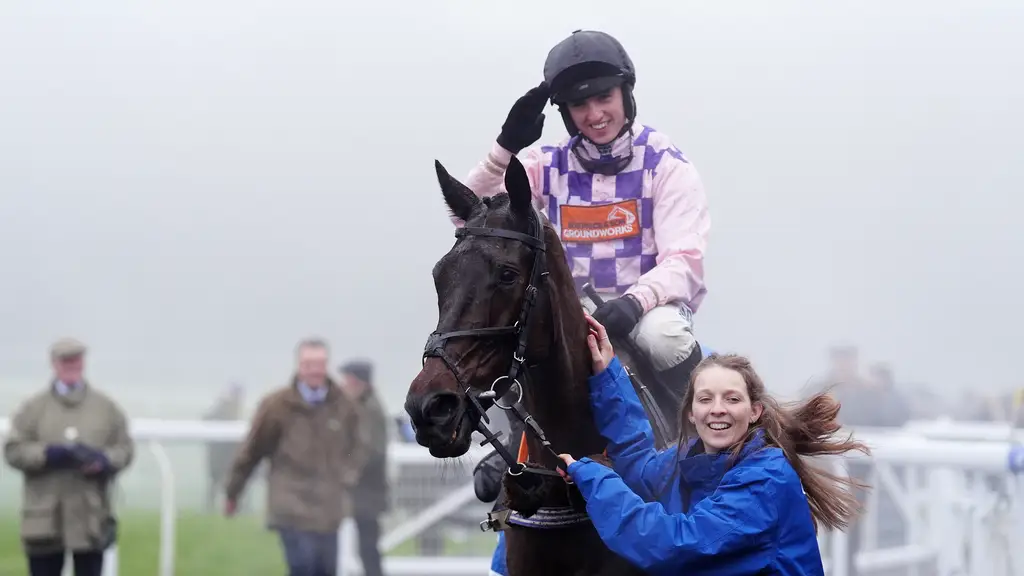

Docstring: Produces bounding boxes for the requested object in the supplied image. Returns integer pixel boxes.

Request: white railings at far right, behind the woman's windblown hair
[822,421,1024,576]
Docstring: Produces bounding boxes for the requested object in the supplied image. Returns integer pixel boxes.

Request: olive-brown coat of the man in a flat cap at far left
[4,383,135,553]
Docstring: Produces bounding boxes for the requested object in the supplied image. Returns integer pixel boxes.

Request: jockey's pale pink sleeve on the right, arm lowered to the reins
[627,153,711,313]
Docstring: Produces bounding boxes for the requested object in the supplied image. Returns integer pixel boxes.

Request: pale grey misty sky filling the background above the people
[0,0,1024,417]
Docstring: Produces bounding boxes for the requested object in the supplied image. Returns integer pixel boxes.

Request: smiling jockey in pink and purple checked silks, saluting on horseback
[466,30,711,391]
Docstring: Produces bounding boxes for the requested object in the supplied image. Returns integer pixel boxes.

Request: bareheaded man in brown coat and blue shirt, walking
[225,339,368,576]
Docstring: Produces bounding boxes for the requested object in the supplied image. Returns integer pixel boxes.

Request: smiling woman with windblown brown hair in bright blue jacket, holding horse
[561,318,867,576]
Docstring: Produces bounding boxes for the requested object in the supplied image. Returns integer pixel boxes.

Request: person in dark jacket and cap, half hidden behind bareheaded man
[339,360,388,576]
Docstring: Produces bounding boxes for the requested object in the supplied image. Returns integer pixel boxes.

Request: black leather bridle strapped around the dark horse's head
[422,207,565,477]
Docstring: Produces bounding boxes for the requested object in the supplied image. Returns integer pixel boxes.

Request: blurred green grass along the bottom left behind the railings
[0,510,495,576]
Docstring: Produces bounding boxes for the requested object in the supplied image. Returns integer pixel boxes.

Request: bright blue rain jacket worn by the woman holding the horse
[568,358,824,576]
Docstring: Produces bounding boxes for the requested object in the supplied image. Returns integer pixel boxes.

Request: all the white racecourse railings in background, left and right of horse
[0,419,1024,576]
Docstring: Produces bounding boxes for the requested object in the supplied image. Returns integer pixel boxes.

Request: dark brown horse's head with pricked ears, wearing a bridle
[406,153,586,457]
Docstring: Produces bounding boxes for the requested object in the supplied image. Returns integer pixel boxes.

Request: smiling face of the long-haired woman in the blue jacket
[689,366,762,454]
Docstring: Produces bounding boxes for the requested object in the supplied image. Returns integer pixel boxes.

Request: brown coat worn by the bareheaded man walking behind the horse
[226,379,369,532]
